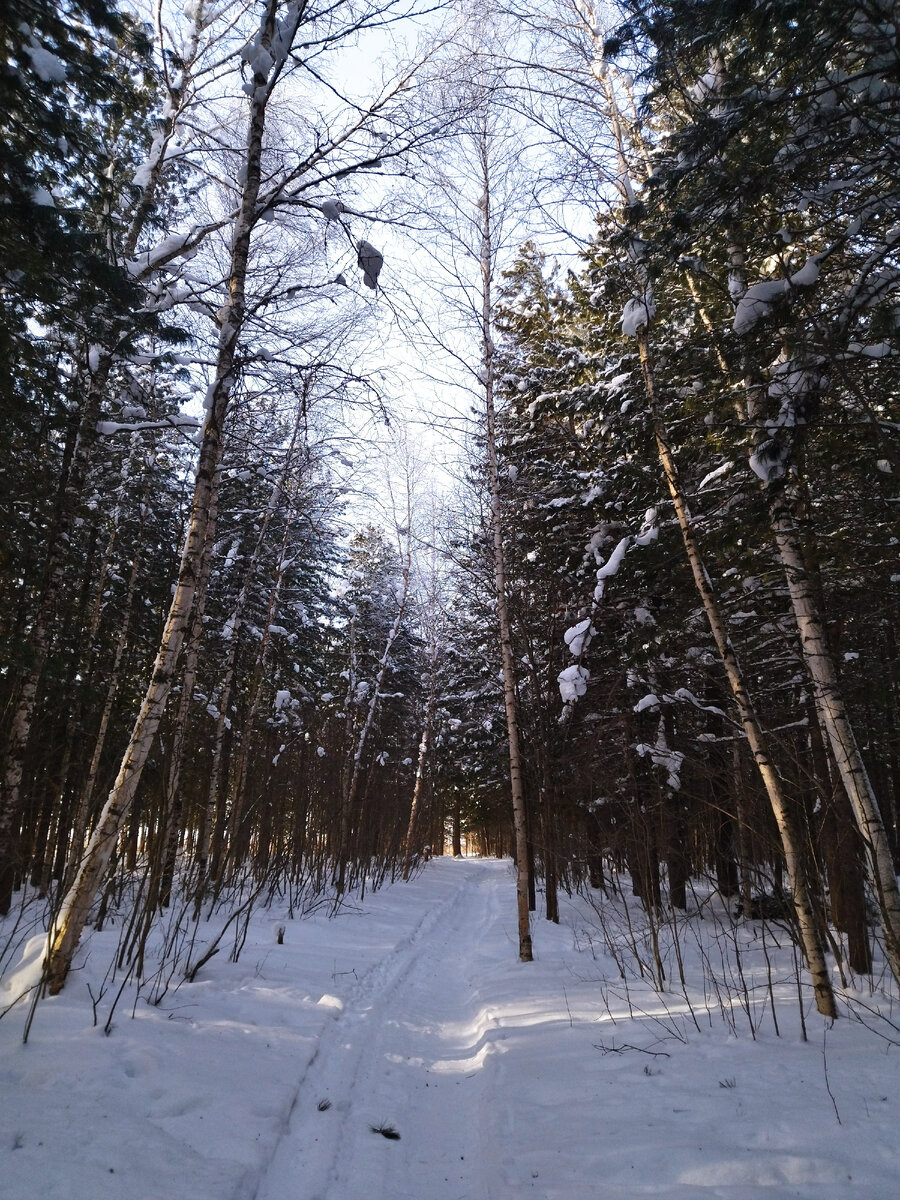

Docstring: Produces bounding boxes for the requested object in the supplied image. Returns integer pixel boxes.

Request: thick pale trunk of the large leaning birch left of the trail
[44,0,276,995]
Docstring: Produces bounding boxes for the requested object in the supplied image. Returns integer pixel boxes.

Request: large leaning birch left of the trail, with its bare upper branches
[46,0,451,991]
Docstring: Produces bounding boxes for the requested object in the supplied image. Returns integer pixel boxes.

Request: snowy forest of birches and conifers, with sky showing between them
[0,0,900,1015]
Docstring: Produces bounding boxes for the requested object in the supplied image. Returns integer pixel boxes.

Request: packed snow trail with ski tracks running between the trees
[253,863,509,1200]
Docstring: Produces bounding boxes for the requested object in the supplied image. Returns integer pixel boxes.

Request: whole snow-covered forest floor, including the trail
[0,859,900,1200]
